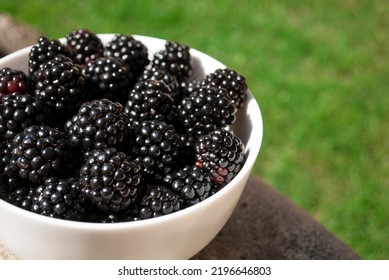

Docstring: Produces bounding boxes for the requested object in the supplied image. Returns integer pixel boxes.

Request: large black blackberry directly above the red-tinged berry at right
[179,87,236,137]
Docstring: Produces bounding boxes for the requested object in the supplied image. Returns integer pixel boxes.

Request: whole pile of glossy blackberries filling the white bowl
[0,29,247,223]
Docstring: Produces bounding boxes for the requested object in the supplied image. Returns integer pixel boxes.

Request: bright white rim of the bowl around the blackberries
[0,33,263,231]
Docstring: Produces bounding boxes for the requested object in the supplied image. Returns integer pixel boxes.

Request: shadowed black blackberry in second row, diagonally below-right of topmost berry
[82,57,134,104]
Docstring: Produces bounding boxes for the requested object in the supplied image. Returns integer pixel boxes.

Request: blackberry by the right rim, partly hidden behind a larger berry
[201,68,247,109]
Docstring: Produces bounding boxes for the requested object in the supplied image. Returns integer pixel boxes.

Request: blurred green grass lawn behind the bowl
[0,0,389,259]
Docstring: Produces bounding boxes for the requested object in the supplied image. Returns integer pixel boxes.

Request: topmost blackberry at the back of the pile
[65,29,104,65]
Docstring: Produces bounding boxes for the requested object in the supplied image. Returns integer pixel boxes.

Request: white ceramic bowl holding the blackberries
[0,34,263,259]
